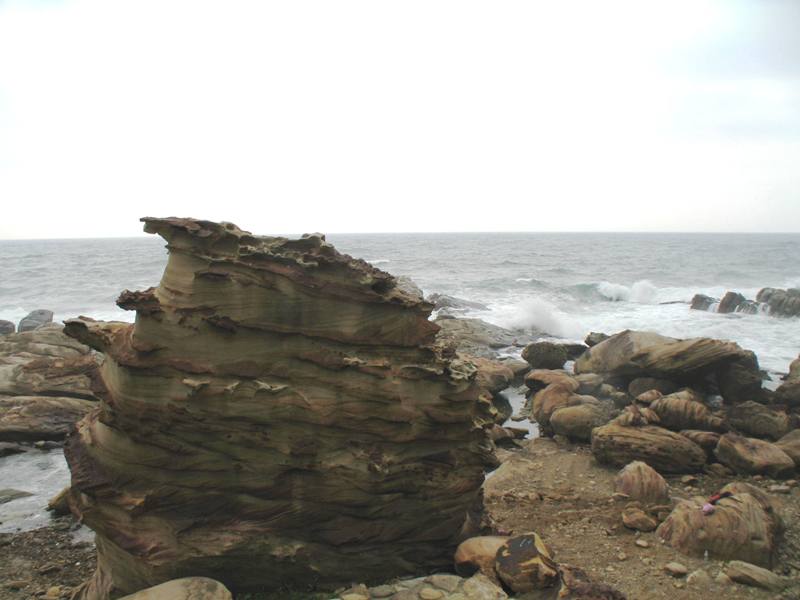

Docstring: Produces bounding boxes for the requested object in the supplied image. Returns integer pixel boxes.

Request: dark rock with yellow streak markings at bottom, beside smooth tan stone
[495,533,559,594]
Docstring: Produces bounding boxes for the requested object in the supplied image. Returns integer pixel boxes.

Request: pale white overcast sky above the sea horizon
[0,0,800,238]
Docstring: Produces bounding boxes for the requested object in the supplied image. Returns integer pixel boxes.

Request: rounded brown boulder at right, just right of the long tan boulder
[714,433,795,477]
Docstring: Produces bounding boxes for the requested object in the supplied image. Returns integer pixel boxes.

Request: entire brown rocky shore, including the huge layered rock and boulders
[0,219,800,600]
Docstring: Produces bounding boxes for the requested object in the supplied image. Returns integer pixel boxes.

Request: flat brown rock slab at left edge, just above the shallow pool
[0,396,97,442]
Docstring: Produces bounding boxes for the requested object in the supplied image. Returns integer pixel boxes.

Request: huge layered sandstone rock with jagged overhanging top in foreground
[66,218,491,598]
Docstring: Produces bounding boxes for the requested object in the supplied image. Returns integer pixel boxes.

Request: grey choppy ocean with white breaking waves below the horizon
[0,233,800,373]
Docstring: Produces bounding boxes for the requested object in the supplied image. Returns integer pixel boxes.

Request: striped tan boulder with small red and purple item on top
[656,483,783,566]
